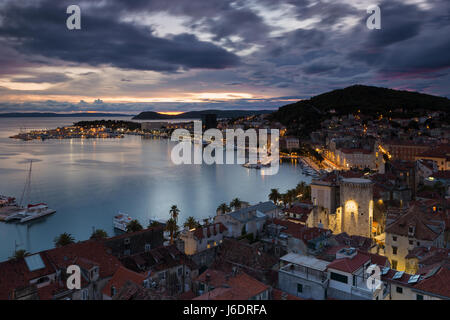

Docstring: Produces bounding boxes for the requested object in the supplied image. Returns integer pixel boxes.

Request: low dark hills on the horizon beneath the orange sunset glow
[133,110,273,120]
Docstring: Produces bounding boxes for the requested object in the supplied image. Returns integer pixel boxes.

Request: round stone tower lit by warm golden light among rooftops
[338,178,373,238]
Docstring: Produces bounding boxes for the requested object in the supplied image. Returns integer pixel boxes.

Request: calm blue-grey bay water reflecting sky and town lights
[0,118,310,260]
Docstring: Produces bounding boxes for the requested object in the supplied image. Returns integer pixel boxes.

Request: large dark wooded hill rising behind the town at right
[272,85,450,136]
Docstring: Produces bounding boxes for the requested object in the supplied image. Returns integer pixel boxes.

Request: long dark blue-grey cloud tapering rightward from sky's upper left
[0,1,239,72]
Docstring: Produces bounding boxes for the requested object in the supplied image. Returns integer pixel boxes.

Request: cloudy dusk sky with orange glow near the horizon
[0,0,450,114]
